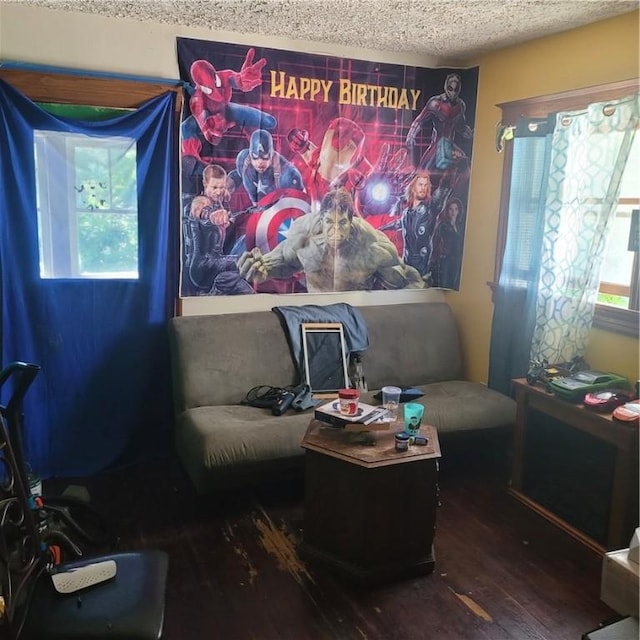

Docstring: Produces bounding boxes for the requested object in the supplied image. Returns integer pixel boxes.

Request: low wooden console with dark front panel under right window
[509,378,638,553]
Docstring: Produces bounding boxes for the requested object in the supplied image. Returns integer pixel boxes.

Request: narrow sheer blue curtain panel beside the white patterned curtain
[488,117,554,394]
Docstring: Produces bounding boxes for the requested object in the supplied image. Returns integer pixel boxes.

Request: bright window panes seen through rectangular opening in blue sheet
[34,131,138,278]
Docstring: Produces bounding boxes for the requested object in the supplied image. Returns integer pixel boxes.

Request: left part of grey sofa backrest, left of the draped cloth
[169,311,297,413]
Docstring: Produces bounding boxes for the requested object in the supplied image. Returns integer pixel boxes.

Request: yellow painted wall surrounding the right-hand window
[446,12,640,380]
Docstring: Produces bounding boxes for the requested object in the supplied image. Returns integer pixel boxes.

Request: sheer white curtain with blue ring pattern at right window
[530,95,639,362]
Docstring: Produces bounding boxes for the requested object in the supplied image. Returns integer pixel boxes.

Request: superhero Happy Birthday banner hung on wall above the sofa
[177,38,478,297]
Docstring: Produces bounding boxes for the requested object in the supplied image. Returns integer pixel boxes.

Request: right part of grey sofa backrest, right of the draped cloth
[360,302,463,389]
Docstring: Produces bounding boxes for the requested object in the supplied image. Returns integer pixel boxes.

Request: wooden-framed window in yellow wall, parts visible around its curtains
[490,79,640,337]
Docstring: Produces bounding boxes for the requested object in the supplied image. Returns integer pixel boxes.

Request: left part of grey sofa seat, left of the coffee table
[175,405,313,490]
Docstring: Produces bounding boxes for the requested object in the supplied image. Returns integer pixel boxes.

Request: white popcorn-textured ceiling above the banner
[4,0,638,61]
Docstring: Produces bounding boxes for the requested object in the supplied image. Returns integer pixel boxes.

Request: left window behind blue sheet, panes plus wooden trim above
[0,65,182,278]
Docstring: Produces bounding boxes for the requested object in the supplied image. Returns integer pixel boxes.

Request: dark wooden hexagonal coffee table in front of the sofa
[300,420,440,583]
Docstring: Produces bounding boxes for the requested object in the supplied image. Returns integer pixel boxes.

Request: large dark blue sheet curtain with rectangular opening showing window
[0,81,177,478]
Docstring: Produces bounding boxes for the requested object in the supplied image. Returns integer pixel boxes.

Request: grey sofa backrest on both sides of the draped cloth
[169,302,462,414]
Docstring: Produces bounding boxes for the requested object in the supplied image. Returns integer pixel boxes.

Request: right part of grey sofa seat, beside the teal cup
[363,380,516,434]
